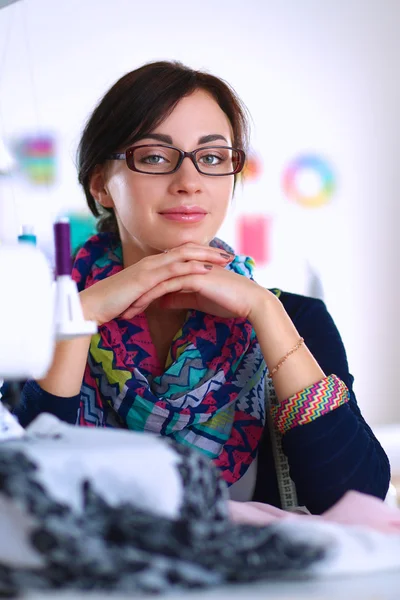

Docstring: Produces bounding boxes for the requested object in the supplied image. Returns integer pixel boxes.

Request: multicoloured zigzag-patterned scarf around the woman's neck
[73,233,266,485]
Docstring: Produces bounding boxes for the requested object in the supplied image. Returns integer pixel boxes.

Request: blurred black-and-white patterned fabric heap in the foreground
[0,414,332,595]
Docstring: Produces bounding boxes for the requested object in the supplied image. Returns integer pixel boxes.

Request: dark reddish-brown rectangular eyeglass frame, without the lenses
[107,144,246,177]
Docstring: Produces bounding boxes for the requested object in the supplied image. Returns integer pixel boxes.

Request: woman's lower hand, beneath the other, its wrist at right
[133,254,270,319]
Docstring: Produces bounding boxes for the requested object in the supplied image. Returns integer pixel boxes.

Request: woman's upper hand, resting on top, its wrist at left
[80,243,232,325]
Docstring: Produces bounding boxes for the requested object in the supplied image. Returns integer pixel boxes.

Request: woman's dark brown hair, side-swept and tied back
[77,61,248,233]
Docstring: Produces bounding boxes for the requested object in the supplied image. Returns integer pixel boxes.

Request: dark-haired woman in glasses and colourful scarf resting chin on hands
[17,62,390,513]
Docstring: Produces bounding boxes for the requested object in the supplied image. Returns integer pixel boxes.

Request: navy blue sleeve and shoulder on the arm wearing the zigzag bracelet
[281,294,390,514]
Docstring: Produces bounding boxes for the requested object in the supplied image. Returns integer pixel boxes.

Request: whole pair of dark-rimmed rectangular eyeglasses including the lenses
[108,144,246,177]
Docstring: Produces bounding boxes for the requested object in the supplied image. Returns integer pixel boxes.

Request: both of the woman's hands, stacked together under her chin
[80,243,269,325]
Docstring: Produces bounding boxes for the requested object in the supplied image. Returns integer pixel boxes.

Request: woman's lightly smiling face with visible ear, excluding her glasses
[92,90,234,259]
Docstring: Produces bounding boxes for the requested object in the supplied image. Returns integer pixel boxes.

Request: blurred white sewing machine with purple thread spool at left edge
[0,219,97,439]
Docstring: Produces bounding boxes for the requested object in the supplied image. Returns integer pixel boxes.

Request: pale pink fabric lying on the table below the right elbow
[229,491,400,535]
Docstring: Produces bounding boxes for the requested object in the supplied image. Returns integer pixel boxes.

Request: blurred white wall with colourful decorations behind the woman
[0,0,400,436]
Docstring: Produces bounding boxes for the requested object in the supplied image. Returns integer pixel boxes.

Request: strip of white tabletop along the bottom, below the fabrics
[21,571,400,600]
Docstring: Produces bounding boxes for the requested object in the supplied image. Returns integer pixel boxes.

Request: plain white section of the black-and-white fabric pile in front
[26,413,182,518]
